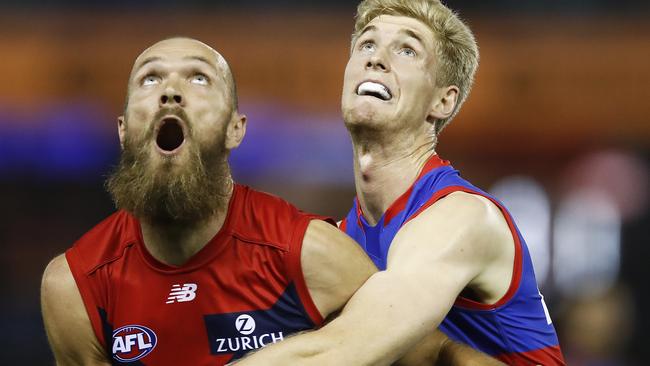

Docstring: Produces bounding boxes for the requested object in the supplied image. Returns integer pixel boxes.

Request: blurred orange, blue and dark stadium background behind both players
[0,0,650,365]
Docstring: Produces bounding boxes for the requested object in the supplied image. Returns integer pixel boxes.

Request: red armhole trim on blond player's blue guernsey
[404,186,523,310]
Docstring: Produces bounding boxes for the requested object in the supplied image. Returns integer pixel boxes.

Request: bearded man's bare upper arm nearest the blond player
[301,220,377,318]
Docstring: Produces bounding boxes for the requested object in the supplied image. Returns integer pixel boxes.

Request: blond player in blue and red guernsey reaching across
[235,0,564,365]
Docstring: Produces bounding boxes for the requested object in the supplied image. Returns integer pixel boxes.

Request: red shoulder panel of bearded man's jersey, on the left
[66,210,139,271]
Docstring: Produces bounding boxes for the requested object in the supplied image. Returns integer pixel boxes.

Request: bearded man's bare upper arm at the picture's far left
[41,255,110,366]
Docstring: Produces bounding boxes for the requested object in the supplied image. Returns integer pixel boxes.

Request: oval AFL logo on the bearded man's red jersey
[113,325,157,362]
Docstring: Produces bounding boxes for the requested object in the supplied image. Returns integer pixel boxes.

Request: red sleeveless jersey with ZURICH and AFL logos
[66,185,323,365]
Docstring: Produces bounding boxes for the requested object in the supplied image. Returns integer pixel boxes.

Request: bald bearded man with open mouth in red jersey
[42,38,375,365]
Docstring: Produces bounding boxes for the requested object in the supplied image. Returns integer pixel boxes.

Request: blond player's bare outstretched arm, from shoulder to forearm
[238,194,505,365]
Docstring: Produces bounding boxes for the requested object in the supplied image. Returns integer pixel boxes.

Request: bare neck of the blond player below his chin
[352,129,435,225]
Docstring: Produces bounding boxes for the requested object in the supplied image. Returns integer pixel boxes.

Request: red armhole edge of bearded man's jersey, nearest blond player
[285,216,323,326]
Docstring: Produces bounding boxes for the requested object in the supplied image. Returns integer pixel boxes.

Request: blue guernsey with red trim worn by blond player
[341,155,565,365]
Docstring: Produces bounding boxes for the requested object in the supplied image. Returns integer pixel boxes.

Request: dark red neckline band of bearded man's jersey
[135,183,243,274]
